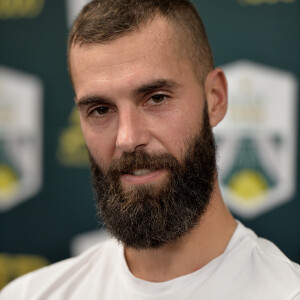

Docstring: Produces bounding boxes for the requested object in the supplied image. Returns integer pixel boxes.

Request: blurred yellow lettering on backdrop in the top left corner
[0,0,45,19]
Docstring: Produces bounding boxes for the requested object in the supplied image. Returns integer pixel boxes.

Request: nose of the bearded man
[116,107,149,152]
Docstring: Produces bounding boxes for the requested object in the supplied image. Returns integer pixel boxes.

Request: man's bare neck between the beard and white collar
[125,183,237,282]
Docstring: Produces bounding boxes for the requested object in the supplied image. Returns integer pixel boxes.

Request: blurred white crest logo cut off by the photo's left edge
[0,67,42,210]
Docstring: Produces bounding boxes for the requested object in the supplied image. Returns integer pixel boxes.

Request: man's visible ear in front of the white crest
[204,68,227,127]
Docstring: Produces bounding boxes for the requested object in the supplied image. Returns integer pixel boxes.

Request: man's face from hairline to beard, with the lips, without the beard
[70,18,217,247]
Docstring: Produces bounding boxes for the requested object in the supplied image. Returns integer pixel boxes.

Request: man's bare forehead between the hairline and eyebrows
[70,16,195,96]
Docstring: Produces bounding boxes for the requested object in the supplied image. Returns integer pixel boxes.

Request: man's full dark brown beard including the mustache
[90,107,216,249]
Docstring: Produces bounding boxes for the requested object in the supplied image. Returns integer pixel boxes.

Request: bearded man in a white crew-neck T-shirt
[1,0,300,300]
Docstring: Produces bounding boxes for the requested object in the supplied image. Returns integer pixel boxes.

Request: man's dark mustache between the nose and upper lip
[107,150,179,176]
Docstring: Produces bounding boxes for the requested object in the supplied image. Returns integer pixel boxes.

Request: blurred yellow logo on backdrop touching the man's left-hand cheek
[57,107,89,167]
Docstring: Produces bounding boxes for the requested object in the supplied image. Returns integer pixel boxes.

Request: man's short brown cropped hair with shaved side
[68,0,214,80]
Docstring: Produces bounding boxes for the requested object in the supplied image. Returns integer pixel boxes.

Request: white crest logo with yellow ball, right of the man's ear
[214,61,297,218]
